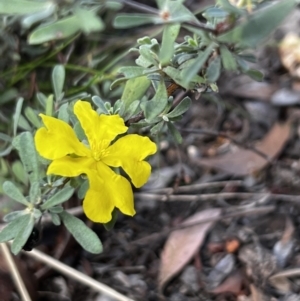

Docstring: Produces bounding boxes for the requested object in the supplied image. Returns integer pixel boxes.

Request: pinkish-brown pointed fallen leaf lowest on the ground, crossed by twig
[159,208,221,291]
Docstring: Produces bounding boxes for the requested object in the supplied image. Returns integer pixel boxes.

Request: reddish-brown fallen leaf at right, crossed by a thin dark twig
[196,122,290,176]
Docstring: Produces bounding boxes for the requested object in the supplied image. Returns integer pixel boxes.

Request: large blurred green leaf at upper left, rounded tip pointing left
[28,15,81,45]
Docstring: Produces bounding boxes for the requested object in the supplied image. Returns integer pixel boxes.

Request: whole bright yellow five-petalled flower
[35,101,156,223]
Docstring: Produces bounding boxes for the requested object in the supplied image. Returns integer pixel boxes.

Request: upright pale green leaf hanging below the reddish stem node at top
[159,23,180,66]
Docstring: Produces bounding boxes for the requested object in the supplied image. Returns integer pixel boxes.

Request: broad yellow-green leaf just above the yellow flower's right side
[121,76,151,108]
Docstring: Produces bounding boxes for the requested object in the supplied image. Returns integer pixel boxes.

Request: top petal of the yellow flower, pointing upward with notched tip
[74,100,127,149]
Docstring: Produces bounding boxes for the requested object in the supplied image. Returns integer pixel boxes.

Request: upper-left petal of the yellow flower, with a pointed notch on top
[34,114,90,160]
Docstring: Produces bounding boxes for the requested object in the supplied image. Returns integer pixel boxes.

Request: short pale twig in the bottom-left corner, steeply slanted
[0,243,31,301]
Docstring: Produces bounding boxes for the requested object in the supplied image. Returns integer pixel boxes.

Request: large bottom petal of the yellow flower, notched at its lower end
[83,162,135,223]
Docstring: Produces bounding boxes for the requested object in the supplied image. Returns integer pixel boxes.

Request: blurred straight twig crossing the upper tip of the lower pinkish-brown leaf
[129,205,276,246]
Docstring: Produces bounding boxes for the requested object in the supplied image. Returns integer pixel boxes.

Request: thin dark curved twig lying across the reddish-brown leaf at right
[180,128,273,164]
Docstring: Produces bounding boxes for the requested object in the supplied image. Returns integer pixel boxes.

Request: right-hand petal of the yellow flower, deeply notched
[102,135,157,187]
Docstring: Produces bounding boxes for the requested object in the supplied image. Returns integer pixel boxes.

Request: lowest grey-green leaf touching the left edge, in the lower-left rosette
[0,210,31,243]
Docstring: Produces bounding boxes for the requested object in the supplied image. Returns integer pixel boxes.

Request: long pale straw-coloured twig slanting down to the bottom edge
[23,249,134,301]
